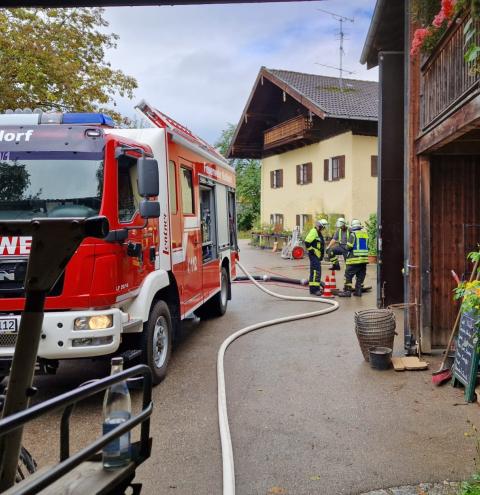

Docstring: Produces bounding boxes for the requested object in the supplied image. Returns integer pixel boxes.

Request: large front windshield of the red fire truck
[0,152,103,220]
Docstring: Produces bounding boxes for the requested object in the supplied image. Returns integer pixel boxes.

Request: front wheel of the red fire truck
[142,301,173,385]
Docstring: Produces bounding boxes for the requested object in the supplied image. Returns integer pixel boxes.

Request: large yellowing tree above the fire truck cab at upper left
[0,8,137,120]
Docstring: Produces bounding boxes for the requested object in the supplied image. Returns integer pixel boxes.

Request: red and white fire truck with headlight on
[0,102,238,383]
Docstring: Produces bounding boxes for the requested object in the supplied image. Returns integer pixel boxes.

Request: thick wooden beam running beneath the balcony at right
[416,95,480,154]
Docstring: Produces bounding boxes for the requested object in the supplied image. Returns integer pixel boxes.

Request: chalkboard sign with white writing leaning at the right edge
[453,313,480,402]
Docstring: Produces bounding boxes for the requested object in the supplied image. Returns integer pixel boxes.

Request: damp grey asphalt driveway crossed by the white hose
[19,243,479,495]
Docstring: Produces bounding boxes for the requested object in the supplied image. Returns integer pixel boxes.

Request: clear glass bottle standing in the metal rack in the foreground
[103,357,132,469]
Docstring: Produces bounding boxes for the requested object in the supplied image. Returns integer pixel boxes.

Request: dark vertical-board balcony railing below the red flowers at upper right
[420,15,480,131]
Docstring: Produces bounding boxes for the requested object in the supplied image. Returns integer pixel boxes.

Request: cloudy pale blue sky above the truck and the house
[106,0,378,143]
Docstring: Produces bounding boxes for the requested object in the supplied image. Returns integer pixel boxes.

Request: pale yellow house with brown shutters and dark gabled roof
[229,67,378,229]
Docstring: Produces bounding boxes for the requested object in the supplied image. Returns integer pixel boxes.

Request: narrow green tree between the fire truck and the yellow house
[215,124,261,230]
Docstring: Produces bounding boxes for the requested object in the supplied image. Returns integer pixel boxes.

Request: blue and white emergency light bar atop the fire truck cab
[0,110,115,127]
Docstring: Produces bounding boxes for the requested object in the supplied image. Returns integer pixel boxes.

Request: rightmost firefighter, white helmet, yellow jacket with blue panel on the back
[343,220,368,297]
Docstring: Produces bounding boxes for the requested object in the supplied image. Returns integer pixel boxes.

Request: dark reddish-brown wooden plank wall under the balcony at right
[430,155,480,347]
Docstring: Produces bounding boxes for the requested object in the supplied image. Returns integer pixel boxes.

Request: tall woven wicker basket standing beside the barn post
[355,309,395,361]
